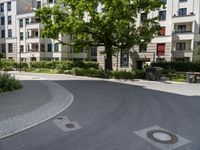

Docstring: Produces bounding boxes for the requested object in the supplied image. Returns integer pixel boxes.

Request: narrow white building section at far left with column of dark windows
[0,0,17,60]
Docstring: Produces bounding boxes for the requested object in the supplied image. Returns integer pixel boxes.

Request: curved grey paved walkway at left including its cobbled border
[0,76,73,139]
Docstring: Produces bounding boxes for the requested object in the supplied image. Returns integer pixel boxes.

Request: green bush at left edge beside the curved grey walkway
[0,73,22,93]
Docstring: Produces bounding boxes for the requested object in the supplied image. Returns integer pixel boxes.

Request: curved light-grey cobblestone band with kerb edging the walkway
[0,81,74,139]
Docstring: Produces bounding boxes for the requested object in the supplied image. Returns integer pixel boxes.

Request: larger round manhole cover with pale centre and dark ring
[146,130,178,144]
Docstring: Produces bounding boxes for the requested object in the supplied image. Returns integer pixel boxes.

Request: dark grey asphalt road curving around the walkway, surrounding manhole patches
[0,80,200,150]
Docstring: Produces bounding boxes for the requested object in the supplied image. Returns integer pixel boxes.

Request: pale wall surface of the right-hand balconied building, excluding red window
[97,0,200,70]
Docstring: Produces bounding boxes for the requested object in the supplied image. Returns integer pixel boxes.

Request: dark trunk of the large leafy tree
[105,45,113,71]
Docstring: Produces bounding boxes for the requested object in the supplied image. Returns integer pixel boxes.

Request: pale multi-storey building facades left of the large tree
[0,0,96,62]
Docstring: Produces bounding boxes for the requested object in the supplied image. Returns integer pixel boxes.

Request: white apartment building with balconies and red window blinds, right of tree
[97,0,200,70]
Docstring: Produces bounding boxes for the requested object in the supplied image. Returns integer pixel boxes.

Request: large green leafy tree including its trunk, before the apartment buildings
[36,0,163,70]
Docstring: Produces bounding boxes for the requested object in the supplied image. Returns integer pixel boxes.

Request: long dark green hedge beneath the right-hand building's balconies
[152,62,200,72]
